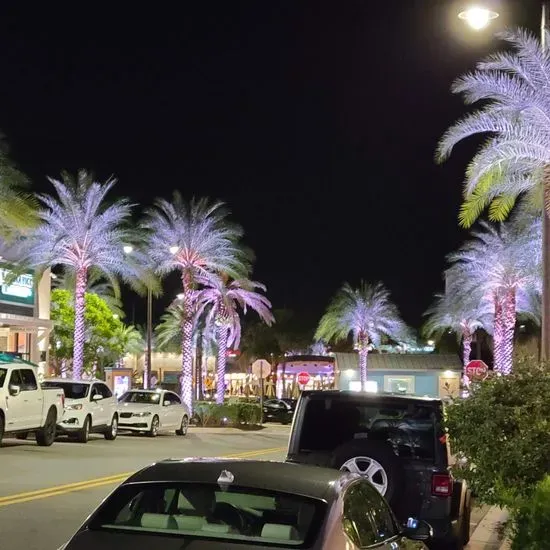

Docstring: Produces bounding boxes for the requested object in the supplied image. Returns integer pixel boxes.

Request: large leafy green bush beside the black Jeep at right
[446,358,550,513]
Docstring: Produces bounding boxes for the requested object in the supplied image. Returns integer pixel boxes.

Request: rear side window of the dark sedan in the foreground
[342,482,379,548]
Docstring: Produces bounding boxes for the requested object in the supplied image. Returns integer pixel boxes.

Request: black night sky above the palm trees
[0,0,539,332]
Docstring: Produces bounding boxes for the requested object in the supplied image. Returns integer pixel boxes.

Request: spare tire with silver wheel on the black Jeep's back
[331,440,405,502]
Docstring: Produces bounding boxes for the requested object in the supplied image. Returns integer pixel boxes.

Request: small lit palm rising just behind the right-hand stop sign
[423,279,493,368]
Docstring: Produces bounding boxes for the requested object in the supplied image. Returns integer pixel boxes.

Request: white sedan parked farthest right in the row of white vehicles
[118,389,190,437]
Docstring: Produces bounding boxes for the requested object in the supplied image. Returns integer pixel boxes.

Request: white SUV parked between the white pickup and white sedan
[42,378,118,443]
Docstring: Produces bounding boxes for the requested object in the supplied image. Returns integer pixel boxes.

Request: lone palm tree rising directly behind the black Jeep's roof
[315,281,409,390]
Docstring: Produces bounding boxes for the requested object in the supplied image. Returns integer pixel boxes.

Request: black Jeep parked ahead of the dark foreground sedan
[287,391,471,550]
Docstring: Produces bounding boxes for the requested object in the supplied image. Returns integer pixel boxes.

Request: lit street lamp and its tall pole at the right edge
[458,0,550,362]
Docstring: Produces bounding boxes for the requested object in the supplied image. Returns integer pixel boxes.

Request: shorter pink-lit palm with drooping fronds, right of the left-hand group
[197,275,275,404]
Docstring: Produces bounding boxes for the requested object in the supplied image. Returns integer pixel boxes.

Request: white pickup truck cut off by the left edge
[0,357,65,447]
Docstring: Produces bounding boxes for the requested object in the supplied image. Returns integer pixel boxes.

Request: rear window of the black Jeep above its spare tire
[300,398,438,460]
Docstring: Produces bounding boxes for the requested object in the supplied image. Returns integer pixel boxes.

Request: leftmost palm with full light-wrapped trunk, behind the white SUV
[26,170,133,379]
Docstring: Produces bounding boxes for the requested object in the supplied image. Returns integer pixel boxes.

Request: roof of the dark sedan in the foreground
[125,458,348,500]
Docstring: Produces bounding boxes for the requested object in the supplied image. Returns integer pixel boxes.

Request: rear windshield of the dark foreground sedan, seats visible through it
[89,482,326,548]
